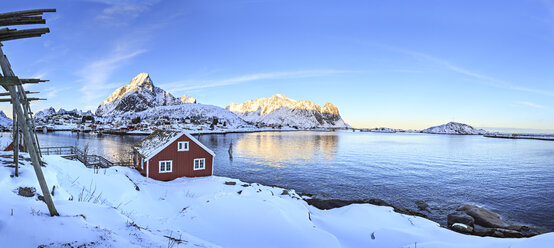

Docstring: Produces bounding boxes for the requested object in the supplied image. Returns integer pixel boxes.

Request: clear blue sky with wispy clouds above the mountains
[1,0,554,129]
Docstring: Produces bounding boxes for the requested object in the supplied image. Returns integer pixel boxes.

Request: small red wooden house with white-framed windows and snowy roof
[133,130,215,181]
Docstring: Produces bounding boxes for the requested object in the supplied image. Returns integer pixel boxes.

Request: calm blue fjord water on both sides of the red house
[39,132,554,231]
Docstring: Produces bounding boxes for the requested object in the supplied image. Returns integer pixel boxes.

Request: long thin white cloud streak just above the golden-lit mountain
[159,70,355,92]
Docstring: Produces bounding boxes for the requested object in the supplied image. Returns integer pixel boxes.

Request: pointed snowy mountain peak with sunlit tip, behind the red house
[96,73,181,116]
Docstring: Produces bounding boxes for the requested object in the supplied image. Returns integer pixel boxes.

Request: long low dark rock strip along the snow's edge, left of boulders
[304,198,428,218]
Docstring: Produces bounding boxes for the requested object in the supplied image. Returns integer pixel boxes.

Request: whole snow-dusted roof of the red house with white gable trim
[133,130,215,160]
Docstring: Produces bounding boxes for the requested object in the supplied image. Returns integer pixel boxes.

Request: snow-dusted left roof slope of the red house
[133,130,183,158]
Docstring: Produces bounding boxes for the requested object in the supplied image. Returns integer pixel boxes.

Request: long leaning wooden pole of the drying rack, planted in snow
[0,46,59,216]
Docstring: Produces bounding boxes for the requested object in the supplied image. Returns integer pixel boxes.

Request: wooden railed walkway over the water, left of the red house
[40,146,134,168]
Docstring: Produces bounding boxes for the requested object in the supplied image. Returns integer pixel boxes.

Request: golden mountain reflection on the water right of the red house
[233,132,339,167]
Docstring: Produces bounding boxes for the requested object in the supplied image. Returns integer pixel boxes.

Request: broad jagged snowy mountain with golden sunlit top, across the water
[226,94,350,128]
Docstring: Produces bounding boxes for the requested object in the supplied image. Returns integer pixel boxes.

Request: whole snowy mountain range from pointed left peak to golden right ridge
[89,73,350,128]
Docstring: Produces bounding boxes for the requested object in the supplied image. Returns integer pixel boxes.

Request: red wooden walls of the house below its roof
[143,135,213,181]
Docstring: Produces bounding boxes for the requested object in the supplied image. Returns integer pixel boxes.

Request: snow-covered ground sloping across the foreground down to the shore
[0,152,554,248]
